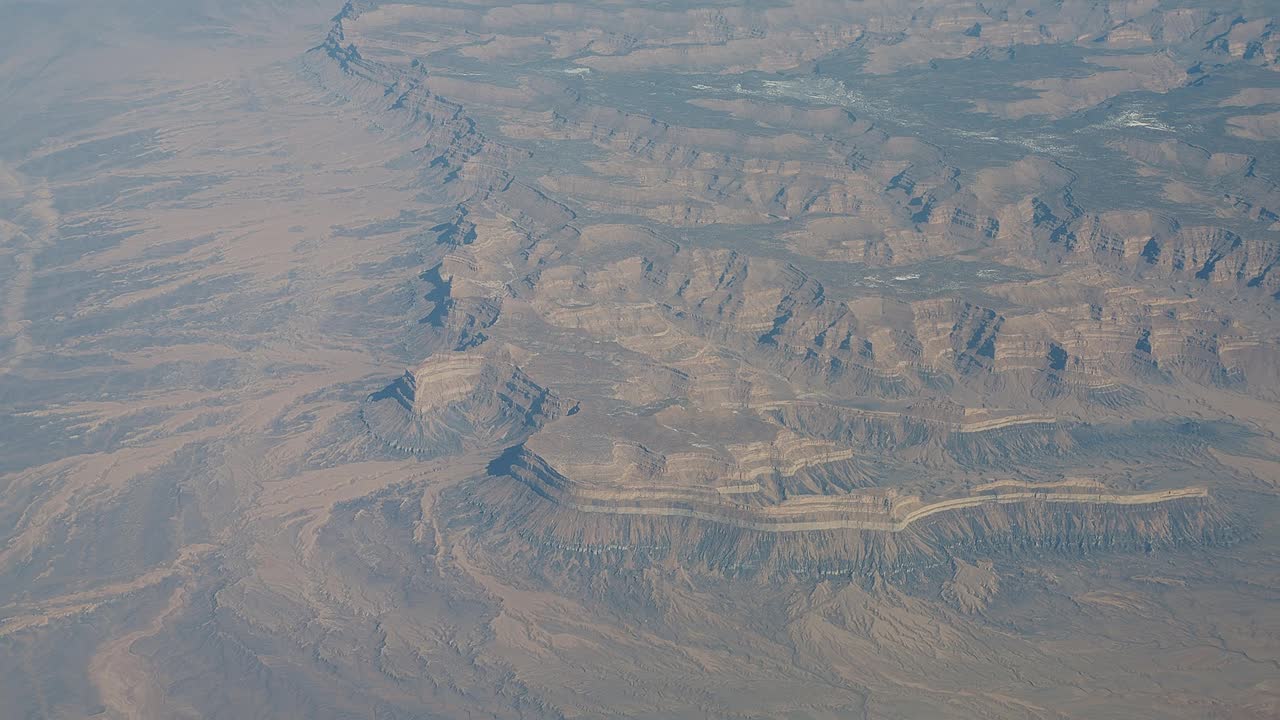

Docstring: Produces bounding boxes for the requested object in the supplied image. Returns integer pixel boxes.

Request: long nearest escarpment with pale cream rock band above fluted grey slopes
[463,440,1235,577]
